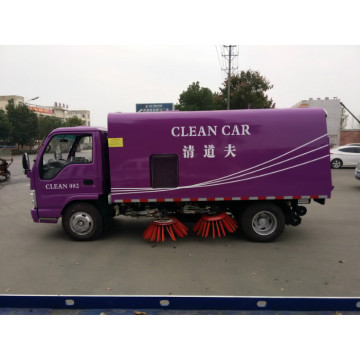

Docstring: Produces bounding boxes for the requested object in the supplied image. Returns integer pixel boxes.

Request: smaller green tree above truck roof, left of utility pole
[175,81,219,111]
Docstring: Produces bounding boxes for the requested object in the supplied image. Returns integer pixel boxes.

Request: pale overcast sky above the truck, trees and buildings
[0,45,360,126]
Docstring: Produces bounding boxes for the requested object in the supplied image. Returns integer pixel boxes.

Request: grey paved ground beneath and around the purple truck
[0,157,360,297]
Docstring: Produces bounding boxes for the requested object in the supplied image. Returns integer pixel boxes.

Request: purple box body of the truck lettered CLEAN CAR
[108,108,333,202]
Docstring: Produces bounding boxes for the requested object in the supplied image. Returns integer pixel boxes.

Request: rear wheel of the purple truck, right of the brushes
[240,202,285,242]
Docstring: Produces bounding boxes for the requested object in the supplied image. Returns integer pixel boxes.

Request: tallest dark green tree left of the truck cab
[6,100,38,147]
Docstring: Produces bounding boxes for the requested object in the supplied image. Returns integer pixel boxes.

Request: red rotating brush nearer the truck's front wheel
[143,217,189,242]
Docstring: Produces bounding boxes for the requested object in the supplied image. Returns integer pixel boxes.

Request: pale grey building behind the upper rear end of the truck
[293,97,343,146]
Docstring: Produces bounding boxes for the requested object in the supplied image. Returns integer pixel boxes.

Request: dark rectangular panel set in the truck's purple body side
[150,154,179,188]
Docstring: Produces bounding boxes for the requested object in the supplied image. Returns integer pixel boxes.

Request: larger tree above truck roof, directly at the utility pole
[215,70,275,109]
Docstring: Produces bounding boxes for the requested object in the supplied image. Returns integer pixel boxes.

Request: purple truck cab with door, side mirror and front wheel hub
[23,127,110,238]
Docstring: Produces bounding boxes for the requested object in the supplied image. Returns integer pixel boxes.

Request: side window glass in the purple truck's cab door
[39,134,93,180]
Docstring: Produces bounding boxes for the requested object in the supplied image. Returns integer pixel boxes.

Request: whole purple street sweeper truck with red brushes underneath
[23,108,333,242]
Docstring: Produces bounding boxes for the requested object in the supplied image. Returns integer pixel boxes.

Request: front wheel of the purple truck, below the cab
[62,202,104,241]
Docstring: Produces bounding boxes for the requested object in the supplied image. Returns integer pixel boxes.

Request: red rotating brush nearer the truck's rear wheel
[193,213,238,239]
